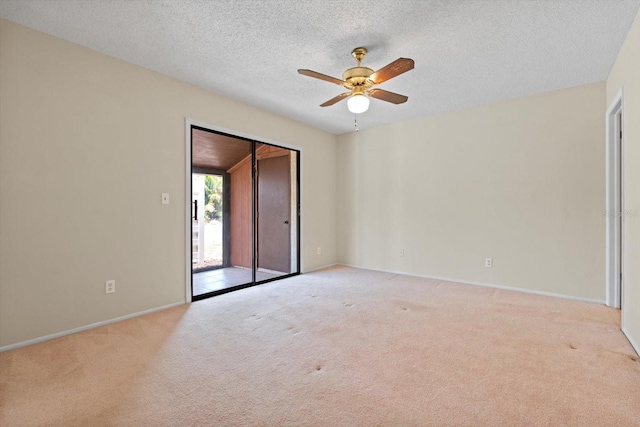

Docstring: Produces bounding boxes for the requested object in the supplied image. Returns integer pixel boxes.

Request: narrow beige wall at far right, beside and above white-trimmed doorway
[606,10,640,351]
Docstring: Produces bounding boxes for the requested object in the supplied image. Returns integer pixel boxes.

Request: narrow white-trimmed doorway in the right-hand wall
[606,89,624,310]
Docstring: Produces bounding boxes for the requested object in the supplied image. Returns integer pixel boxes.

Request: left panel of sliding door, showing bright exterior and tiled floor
[191,128,253,300]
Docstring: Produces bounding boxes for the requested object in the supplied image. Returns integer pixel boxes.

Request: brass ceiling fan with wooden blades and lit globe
[298,47,414,114]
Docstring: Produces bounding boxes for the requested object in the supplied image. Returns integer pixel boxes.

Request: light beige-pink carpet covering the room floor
[0,267,640,427]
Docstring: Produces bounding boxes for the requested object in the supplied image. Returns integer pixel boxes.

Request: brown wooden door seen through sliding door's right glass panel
[257,155,291,273]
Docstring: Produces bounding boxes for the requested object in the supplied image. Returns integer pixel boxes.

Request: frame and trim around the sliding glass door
[183,117,304,304]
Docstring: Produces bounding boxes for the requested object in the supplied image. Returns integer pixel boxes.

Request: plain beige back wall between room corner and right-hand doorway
[338,83,605,301]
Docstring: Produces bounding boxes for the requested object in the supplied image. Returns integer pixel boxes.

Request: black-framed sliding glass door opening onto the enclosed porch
[186,122,300,301]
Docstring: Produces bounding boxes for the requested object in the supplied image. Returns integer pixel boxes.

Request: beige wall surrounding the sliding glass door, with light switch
[0,20,337,347]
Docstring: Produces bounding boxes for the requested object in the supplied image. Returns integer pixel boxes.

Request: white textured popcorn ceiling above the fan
[0,0,640,134]
